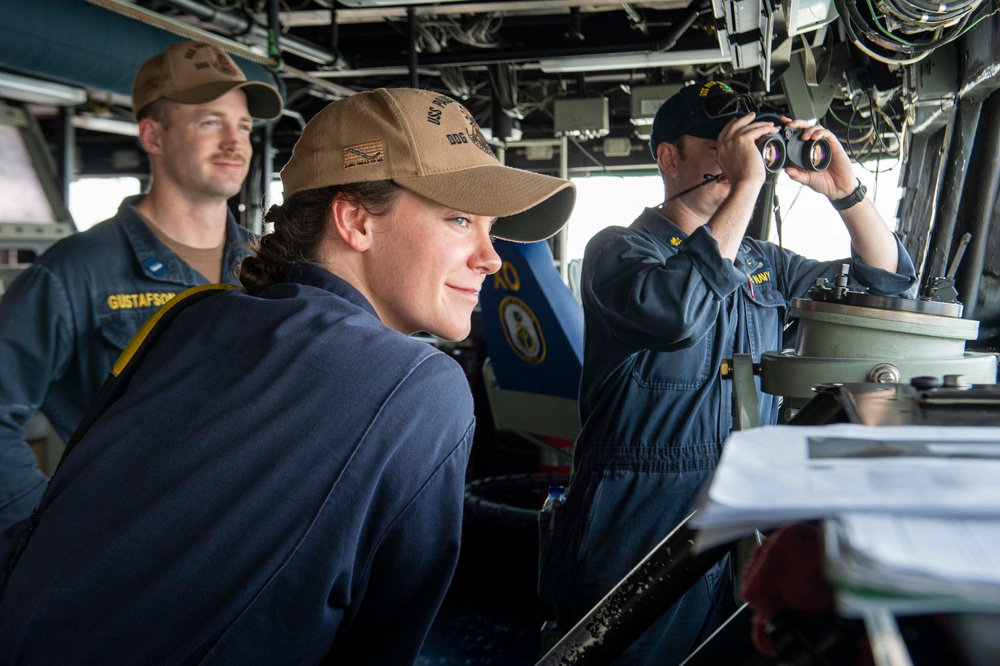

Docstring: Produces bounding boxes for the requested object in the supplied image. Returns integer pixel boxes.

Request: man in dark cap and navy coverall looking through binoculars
[540,81,916,665]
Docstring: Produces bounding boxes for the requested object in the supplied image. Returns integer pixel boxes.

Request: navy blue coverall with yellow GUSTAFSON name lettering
[0,195,250,530]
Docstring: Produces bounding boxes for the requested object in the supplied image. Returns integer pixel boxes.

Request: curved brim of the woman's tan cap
[393,164,576,243]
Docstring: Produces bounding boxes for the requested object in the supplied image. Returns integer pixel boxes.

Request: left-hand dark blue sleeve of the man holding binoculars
[582,227,746,351]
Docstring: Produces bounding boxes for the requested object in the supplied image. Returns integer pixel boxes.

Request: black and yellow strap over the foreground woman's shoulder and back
[0,284,239,599]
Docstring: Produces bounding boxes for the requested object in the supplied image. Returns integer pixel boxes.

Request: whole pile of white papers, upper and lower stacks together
[690,424,1000,614]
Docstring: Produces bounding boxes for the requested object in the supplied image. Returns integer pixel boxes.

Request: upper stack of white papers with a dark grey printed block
[691,424,1000,548]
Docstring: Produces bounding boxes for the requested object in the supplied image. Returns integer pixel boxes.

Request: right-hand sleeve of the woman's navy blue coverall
[330,354,474,665]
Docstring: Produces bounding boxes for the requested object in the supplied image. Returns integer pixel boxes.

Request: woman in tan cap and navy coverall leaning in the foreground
[0,89,575,665]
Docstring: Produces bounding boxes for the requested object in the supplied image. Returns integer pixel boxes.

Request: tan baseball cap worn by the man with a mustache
[132,42,284,120]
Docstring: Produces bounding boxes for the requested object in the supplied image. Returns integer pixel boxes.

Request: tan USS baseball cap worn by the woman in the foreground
[281,88,576,242]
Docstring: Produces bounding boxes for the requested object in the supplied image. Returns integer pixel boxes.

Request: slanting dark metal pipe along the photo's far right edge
[955,94,1000,319]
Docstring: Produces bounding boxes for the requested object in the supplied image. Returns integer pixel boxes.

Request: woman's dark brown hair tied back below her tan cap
[238,180,403,294]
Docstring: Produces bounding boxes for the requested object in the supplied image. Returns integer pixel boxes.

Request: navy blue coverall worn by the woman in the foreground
[0,266,475,666]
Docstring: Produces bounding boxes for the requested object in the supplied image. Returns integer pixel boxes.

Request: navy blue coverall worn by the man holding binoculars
[541,209,915,666]
